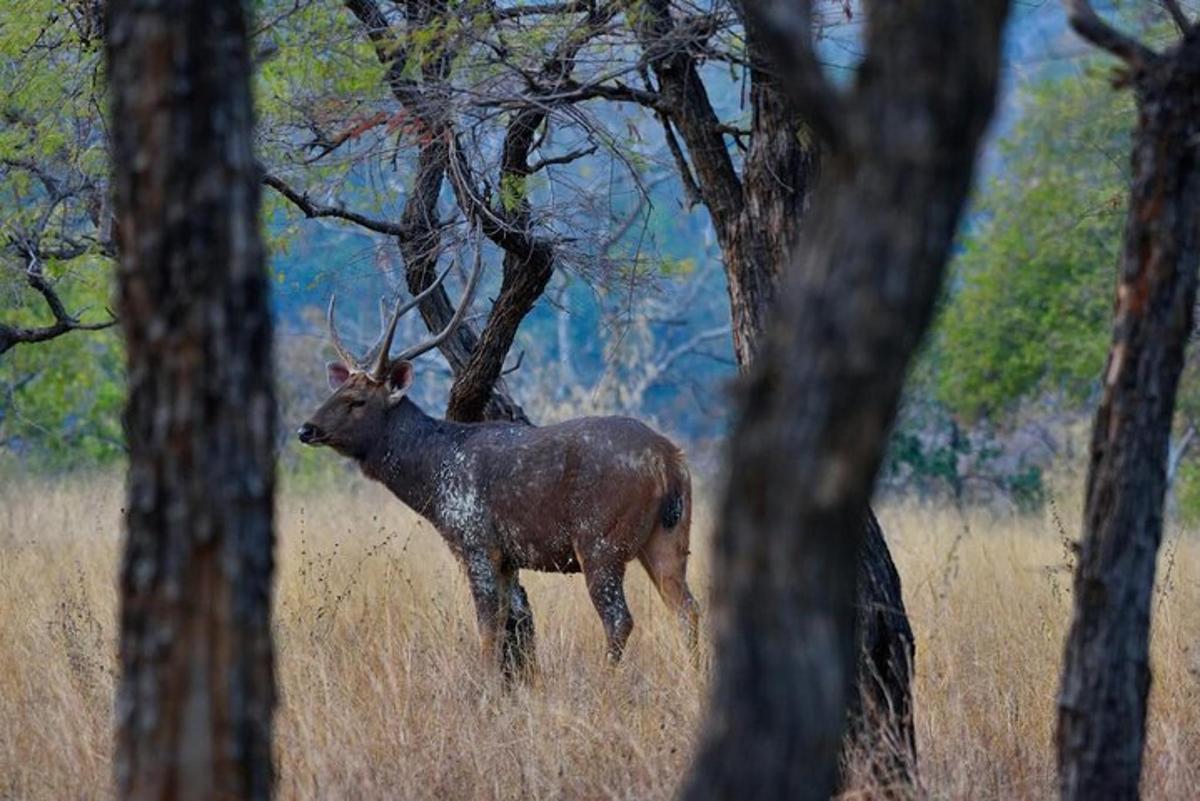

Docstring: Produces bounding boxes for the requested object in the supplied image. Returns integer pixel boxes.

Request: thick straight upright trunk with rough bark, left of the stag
[108,0,276,801]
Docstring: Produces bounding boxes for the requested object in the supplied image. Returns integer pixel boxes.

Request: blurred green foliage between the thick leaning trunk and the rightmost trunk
[930,64,1134,418]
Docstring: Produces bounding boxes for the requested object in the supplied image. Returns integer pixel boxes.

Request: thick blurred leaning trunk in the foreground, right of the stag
[684,0,1008,801]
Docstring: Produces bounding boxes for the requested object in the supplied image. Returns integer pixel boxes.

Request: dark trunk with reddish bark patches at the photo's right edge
[1057,18,1200,801]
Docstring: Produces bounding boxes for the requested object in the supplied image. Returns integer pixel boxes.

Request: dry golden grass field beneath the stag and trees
[0,477,1200,801]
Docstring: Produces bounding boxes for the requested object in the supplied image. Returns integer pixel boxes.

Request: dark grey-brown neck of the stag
[361,398,468,523]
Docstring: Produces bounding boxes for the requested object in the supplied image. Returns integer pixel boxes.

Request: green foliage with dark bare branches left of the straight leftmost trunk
[0,0,121,464]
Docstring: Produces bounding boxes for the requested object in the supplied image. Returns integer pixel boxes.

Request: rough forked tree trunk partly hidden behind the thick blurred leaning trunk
[641,0,916,783]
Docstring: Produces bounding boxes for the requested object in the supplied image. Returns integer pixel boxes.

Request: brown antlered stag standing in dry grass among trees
[299,244,698,663]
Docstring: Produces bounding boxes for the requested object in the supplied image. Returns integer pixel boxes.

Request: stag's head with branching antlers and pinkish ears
[296,237,482,458]
